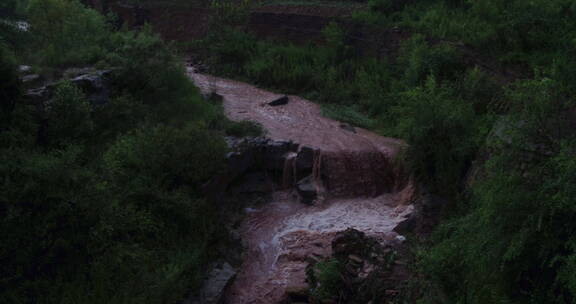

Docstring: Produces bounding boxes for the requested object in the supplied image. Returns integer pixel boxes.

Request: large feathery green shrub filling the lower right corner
[422,79,576,303]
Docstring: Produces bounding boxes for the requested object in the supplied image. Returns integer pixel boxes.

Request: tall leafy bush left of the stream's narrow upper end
[106,28,216,125]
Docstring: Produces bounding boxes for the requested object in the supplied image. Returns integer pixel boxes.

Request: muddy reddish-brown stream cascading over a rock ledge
[189,68,412,304]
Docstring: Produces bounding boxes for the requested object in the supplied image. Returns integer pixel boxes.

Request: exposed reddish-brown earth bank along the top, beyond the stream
[99,0,410,56]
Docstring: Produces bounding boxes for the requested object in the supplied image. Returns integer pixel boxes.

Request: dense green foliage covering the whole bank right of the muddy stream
[201,0,576,303]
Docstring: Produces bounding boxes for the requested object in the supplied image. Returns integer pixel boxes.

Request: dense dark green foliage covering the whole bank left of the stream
[0,0,248,304]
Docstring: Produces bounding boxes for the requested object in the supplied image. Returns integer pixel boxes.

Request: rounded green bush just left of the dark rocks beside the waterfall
[104,124,225,190]
